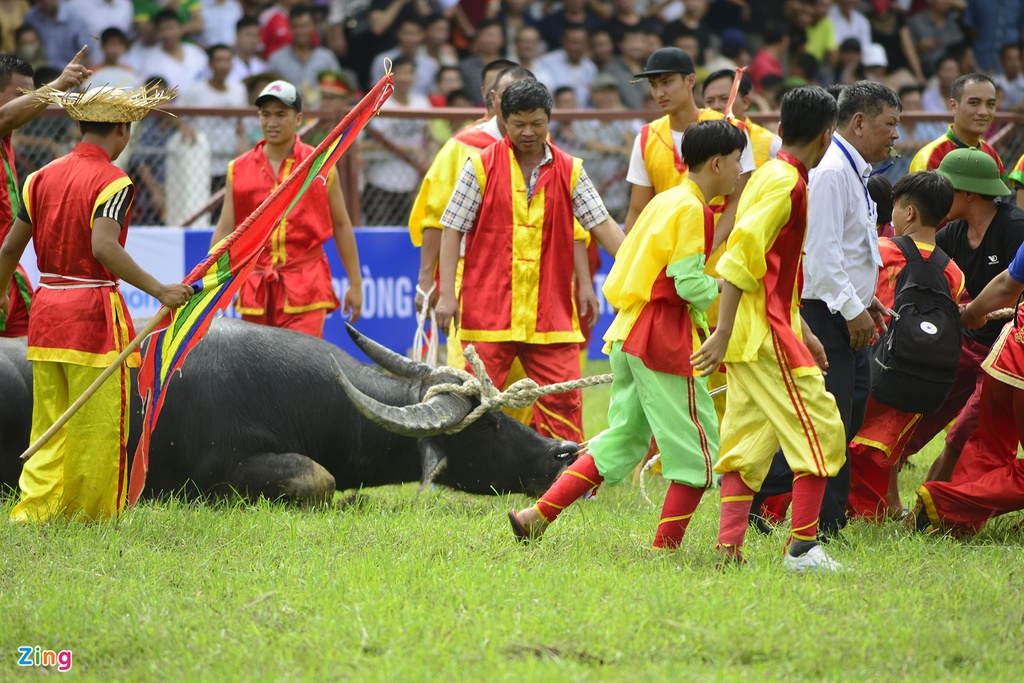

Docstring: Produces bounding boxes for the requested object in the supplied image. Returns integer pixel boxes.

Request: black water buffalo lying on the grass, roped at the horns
[0,318,577,502]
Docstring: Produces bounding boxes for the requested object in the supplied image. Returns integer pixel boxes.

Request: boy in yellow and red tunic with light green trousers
[509,121,746,548]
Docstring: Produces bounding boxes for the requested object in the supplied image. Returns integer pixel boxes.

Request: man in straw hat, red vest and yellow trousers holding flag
[0,86,193,521]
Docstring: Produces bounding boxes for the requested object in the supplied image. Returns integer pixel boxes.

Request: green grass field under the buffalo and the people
[0,364,1024,683]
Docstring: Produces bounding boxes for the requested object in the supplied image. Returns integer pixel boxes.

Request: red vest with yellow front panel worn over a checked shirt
[461,137,583,343]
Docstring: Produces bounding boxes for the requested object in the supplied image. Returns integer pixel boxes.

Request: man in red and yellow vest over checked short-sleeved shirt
[436,80,623,441]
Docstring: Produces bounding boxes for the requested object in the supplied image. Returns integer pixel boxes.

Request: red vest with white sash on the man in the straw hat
[24,142,138,367]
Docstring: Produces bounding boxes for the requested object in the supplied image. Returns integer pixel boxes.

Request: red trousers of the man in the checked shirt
[463,341,583,443]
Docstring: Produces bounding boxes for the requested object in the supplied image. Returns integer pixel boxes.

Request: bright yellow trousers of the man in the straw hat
[10,360,129,521]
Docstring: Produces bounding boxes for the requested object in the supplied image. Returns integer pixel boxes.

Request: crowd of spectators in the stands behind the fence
[0,0,1024,223]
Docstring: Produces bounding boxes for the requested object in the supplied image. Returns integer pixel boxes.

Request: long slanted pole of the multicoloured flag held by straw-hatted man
[20,70,393,462]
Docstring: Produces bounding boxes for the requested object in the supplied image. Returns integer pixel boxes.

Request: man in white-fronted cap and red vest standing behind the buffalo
[212,81,362,337]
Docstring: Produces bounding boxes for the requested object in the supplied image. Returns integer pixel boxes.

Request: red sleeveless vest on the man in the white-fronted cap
[229,136,340,315]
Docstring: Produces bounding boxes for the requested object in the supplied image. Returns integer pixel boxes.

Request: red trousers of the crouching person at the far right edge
[918,375,1024,533]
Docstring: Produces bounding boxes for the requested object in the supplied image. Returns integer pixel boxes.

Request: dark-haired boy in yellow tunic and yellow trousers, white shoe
[692,87,846,572]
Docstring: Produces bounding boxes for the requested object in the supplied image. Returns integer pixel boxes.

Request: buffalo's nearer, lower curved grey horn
[338,362,472,438]
